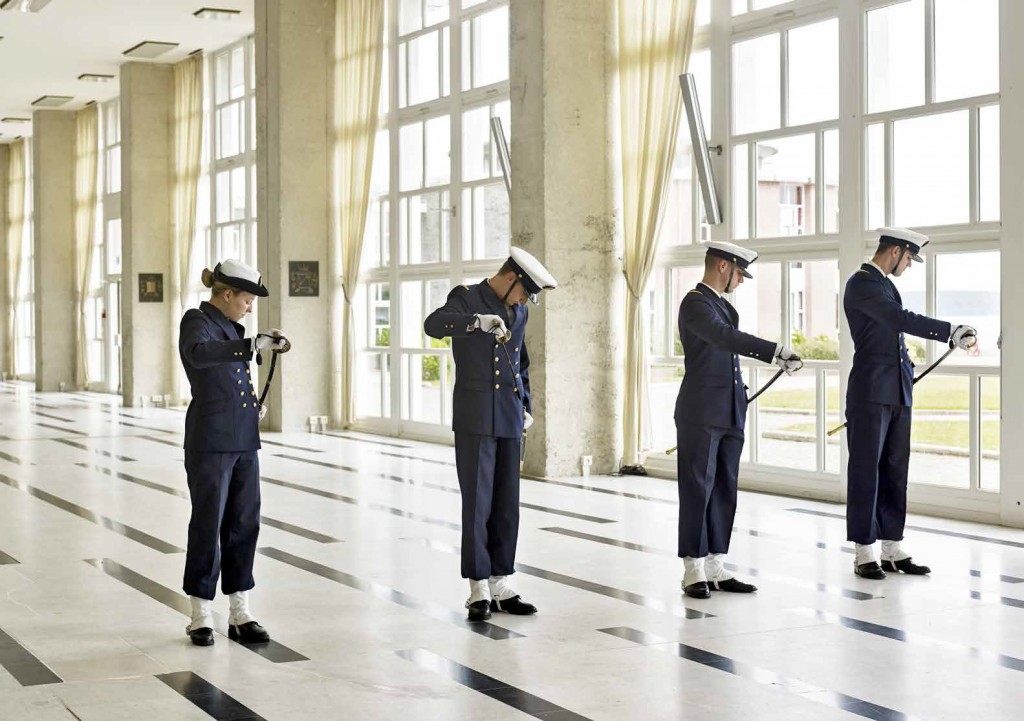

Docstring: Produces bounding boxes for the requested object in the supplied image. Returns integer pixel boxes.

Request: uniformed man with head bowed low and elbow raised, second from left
[423,248,558,621]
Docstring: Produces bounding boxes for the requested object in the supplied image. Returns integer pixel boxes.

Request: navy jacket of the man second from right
[676,284,775,428]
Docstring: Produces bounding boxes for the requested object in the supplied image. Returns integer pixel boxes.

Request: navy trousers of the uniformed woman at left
[183,451,260,600]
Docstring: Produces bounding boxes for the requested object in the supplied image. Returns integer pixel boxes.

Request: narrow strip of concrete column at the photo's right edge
[999,0,1024,527]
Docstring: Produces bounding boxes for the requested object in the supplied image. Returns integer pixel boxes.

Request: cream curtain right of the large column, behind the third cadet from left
[615,0,696,466]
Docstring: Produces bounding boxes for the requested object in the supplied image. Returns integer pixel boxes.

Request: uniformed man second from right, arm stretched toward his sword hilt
[675,242,802,598]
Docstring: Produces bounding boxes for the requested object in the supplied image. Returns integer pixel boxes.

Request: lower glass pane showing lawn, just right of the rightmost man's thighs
[909,372,971,489]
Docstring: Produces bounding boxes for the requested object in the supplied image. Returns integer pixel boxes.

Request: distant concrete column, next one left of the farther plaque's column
[27,111,76,391]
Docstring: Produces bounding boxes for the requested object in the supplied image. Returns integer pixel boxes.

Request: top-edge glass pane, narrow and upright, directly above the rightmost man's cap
[867,0,925,113]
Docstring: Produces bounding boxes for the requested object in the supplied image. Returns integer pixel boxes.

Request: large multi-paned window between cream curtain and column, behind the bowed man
[356,0,512,436]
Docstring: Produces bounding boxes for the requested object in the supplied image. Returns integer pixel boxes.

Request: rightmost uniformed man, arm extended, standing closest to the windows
[843,228,977,580]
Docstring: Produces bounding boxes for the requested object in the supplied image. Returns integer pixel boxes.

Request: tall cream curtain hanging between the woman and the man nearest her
[331,0,384,426]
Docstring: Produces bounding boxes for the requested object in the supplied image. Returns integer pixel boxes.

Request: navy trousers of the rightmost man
[846,402,911,544]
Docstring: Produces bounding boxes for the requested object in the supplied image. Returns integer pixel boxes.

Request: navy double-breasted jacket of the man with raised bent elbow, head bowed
[423,281,532,438]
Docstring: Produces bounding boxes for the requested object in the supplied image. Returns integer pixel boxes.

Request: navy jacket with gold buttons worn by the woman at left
[178,301,260,453]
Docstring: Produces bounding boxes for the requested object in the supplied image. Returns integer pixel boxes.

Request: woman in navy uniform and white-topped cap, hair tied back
[178,260,288,646]
